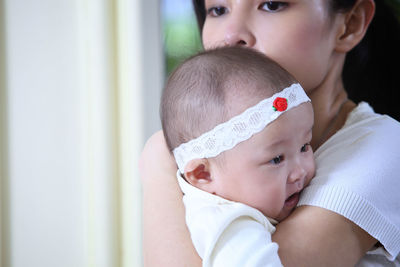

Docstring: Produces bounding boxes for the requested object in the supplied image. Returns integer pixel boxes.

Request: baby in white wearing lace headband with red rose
[161,47,315,267]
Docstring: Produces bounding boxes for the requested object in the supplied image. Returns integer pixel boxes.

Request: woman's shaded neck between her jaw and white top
[309,58,356,150]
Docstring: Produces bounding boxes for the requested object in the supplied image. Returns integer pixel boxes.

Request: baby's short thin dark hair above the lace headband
[160,47,296,151]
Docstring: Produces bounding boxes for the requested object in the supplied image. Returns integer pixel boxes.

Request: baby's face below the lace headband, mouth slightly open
[211,102,315,221]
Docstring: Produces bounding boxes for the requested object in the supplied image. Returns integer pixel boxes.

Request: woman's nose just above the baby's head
[224,21,256,47]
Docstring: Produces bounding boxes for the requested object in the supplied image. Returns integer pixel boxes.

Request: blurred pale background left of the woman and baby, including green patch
[0,0,201,267]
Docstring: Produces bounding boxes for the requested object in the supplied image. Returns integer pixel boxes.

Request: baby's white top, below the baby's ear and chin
[177,174,282,267]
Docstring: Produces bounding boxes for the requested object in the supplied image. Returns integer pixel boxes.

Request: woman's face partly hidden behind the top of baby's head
[202,0,340,92]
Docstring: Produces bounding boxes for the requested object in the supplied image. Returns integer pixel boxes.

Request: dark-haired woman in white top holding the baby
[140,0,400,266]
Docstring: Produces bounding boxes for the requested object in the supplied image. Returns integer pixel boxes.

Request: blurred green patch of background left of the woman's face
[164,17,202,75]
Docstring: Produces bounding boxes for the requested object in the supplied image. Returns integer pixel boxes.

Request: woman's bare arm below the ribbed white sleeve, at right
[272,206,377,267]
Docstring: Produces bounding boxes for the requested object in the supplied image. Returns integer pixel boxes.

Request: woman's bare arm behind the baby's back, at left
[139,131,201,267]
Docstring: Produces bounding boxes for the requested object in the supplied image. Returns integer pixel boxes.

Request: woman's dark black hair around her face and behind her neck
[193,0,400,121]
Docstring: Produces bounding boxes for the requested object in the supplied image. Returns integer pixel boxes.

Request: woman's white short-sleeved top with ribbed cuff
[298,103,400,266]
